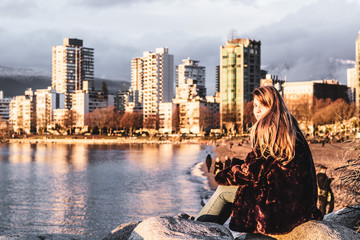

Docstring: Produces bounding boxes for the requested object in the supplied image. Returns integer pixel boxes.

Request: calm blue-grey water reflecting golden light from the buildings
[0,144,211,239]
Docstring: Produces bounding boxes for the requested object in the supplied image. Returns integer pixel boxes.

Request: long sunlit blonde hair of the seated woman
[251,86,298,164]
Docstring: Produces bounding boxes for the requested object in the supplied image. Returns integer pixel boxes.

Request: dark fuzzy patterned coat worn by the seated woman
[215,131,323,234]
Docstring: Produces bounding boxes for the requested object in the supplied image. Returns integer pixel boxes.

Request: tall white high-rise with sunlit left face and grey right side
[132,48,174,129]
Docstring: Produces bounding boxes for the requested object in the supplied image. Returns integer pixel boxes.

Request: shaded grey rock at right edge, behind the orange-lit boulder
[324,205,360,230]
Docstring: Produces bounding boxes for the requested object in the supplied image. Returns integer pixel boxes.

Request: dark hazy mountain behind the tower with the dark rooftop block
[0,66,130,97]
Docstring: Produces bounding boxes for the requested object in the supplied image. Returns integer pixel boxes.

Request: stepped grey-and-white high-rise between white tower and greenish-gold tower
[176,58,206,100]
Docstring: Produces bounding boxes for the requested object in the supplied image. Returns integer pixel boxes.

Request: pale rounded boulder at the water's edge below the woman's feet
[129,217,234,240]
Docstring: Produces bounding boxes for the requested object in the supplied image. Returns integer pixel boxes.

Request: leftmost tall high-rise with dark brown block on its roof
[52,38,94,109]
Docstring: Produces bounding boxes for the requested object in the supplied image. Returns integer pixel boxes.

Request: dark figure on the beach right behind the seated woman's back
[316,165,335,215]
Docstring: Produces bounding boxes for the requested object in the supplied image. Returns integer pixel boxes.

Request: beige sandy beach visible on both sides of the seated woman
[202,141,360,210]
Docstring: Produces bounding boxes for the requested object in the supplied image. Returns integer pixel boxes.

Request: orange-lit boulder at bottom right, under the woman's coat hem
[264,220,360,240]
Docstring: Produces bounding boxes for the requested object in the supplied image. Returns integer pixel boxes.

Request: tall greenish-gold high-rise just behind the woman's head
[220,39,262,133]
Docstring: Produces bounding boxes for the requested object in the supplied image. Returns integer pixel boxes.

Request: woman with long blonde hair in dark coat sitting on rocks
[196,86,323,234]
